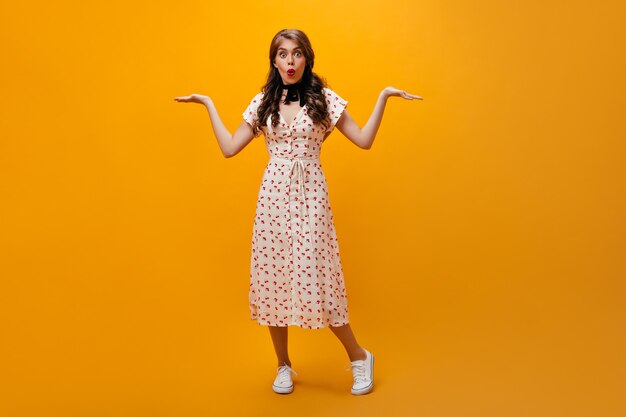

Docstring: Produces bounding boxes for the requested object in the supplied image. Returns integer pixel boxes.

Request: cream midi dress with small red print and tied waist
[243,88,348,329]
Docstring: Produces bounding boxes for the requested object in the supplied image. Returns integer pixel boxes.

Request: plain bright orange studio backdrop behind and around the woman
[0,1,626,417]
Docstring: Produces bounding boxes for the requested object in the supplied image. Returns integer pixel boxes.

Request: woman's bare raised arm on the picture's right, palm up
[335,87,423,149]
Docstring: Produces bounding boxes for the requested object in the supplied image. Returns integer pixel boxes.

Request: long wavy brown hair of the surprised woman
[252,29,330,136]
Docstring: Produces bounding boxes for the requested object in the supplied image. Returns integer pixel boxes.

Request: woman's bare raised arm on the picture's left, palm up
[174,94,254,158]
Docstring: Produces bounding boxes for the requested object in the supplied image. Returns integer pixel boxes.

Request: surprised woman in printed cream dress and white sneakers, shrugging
[175,29,422,395]
